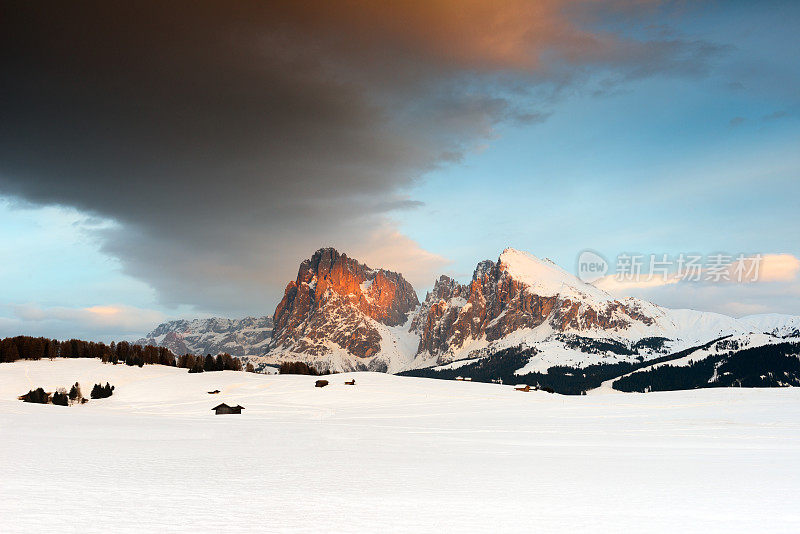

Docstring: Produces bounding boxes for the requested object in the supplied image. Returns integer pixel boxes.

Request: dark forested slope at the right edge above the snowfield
[613,342,800,392]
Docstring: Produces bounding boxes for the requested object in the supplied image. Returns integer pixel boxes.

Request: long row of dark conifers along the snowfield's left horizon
[0,336,247,373]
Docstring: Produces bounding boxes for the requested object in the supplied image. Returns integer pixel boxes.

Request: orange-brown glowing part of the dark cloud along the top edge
[264,0,659,70]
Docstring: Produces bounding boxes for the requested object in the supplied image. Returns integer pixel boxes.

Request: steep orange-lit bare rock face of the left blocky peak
[270,248,419,364]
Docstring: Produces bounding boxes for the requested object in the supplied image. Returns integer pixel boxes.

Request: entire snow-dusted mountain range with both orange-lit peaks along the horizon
[139,248,800,390]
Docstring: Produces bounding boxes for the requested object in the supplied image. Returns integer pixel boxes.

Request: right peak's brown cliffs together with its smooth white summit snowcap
[411,249,654,363]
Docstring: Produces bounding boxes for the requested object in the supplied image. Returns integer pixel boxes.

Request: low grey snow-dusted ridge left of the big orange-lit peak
[136,317,272,357]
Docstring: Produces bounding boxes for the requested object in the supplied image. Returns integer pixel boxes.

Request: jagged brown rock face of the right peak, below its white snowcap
[411,252,653,364]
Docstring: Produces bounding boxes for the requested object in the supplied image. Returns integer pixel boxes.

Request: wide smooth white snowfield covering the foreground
[0,360,800,532]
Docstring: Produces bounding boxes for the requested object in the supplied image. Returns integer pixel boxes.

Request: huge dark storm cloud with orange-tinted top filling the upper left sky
[0,0,715,312]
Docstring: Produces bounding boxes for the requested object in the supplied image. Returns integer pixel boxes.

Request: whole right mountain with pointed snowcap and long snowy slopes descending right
[411,249,780,370]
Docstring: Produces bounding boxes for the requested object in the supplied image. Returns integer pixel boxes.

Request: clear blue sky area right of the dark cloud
[402,3,800,275]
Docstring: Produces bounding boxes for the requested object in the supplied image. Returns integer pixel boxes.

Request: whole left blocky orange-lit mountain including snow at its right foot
[265,248,419,372]
